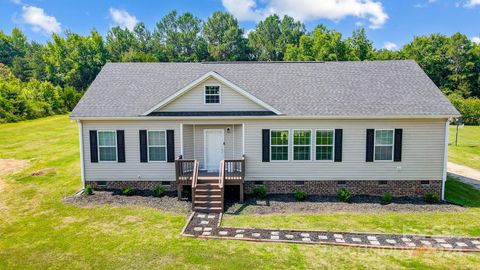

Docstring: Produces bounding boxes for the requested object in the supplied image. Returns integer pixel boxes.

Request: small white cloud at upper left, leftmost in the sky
[22,6,62,34]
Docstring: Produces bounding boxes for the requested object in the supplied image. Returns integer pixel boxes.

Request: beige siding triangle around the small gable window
[155,78,266,112]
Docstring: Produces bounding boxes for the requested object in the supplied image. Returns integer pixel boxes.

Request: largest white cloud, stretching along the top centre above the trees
[222,0,388,29]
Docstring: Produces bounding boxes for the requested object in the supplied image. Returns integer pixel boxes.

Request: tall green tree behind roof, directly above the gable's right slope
[203,11,247,61]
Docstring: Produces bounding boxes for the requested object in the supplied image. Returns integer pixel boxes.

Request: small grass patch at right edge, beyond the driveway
[448,126,480,170]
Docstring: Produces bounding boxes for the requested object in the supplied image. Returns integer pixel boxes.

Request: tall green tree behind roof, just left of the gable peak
[154,11,208,62]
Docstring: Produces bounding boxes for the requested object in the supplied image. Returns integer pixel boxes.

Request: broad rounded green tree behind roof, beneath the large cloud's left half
[248,14,305,61]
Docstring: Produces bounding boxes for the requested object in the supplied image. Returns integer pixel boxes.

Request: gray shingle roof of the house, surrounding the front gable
[71,60,458,117]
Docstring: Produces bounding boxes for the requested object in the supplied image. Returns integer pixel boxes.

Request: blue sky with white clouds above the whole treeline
[0,0,480,49]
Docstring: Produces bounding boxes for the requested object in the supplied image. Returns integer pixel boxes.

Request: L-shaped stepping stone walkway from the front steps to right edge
[182,212,480,252]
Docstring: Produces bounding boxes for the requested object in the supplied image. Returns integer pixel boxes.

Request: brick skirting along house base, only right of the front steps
[244,180,442,196]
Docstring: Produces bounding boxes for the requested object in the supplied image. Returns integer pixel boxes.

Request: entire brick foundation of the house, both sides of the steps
[87,180,442,196]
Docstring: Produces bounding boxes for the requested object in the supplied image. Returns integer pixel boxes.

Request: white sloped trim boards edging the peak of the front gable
[142,71,282,116]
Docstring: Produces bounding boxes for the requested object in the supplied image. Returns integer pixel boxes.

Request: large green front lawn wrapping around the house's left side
[0,116,480,269]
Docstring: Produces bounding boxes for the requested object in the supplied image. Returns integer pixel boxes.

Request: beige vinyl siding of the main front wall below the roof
[82,119,445,181]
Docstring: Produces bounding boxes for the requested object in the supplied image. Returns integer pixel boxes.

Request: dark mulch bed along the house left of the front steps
[63,191,192,214]
